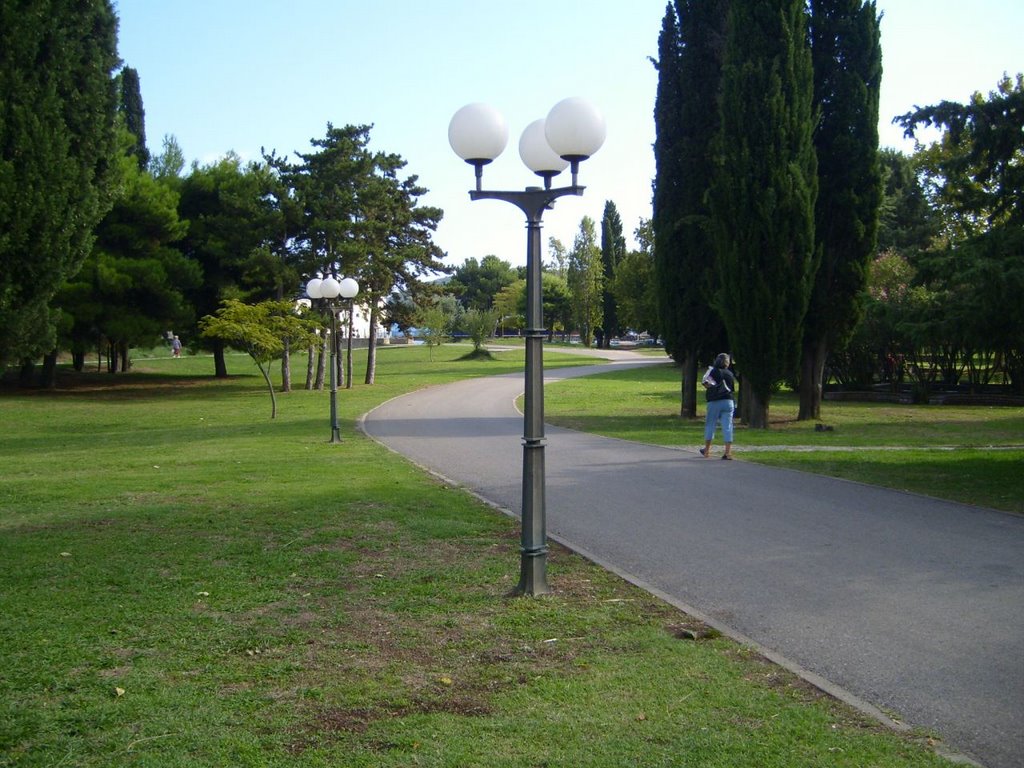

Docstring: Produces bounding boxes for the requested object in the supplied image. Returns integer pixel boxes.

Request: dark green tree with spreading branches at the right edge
[898,75,1024,391]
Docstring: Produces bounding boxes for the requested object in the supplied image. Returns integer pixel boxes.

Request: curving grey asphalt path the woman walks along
[362,354,1024,768]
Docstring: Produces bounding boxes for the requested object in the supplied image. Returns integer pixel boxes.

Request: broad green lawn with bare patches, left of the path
[0,346,958,768]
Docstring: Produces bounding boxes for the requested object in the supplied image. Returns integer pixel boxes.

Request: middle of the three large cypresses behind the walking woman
[711,0,817,428]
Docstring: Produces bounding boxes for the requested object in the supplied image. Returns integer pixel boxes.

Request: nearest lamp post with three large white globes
[449,98,605,595]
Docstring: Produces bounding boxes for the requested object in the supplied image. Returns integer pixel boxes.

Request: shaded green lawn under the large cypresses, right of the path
[545,365,1024,513]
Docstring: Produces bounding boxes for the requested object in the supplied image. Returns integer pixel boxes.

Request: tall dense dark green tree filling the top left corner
[0,0,119,371]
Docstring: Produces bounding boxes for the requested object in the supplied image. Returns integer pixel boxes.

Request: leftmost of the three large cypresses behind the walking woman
[653,0,729,418]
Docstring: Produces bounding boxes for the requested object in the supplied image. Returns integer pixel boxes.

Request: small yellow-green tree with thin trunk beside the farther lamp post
[199,299,314,419]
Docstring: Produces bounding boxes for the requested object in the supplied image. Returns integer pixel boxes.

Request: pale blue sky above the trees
[116,0,1024,272]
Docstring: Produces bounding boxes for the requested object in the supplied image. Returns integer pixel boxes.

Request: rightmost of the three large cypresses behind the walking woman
[798,0,882,419]
